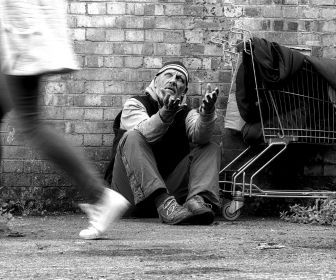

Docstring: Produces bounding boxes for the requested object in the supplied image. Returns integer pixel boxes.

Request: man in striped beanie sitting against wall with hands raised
[111,61,221,225]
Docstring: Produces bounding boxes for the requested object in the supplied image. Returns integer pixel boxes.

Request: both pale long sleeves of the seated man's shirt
[120,98,217,144]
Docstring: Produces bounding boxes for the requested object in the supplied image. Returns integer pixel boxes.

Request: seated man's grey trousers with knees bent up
[112,130,221,214]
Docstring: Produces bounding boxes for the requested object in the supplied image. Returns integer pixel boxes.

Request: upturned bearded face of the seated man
[156,69,187,99]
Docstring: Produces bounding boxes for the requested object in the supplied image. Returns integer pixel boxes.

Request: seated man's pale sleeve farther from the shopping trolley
[120,98,169,143]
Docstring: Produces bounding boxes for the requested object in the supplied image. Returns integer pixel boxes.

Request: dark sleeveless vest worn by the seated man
[104,95,190,184]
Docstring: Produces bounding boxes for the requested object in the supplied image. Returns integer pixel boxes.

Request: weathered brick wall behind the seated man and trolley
[1,0,336,209]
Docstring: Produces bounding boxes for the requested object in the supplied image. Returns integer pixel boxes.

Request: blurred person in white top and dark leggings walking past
[0,0,128,239]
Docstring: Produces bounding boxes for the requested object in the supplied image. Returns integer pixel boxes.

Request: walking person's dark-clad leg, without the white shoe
[6,76,104,202]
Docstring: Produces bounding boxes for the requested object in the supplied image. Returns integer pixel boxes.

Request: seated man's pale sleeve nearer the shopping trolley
[186,109,217,145]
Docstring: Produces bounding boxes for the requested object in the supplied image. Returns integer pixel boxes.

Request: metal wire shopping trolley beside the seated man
[211,30,336,220]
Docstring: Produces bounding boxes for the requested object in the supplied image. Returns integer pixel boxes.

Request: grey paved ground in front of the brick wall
[0,215,336,280]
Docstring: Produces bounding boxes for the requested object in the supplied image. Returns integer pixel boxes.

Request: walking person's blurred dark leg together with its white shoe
[7,76,129,239]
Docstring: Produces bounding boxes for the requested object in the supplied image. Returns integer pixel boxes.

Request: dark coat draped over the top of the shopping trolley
[236,38,336,144]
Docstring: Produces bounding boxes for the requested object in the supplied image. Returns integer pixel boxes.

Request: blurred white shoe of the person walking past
[79,188,130,239]
